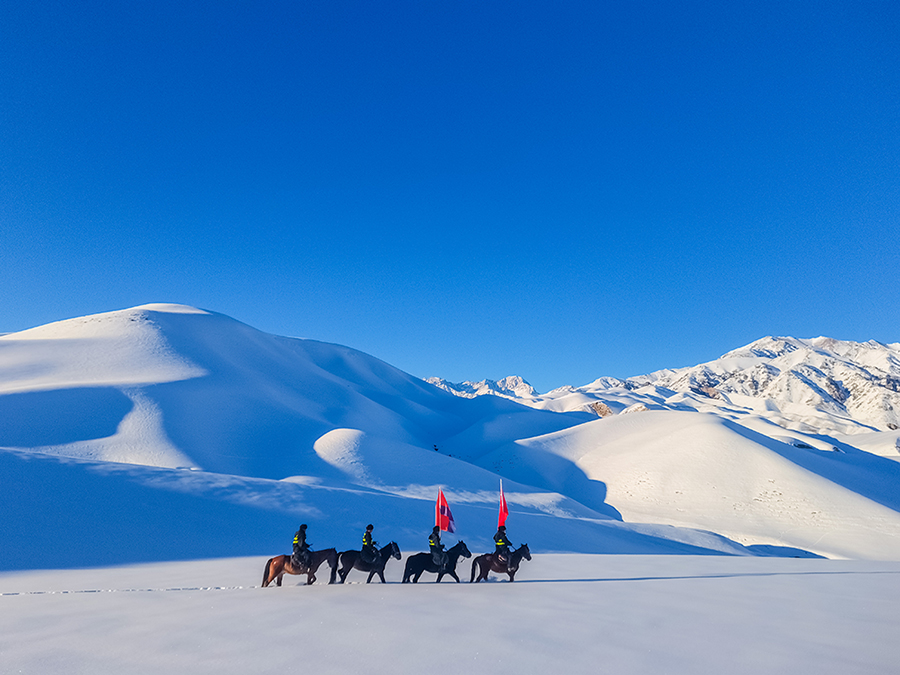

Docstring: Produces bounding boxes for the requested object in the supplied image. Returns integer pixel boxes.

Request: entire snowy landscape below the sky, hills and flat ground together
[0,304,900,675]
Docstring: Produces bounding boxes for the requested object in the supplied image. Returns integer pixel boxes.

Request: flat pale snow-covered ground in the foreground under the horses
[0,554,900,675]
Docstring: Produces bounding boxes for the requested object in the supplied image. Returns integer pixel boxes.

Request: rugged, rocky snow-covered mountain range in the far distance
[427,337,900,434]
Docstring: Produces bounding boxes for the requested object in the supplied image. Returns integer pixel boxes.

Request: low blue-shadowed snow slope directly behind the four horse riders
[0,451,750,570]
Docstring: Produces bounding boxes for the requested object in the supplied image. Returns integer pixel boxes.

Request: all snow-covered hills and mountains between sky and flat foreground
[0,305,900,569]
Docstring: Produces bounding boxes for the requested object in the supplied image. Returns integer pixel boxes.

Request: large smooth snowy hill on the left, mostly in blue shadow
[0,305,581,478]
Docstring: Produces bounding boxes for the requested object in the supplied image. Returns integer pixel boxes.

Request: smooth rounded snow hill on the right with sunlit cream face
[496,411,900,560]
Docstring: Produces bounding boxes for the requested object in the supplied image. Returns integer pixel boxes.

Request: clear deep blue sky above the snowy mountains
[0,0,900,391]
